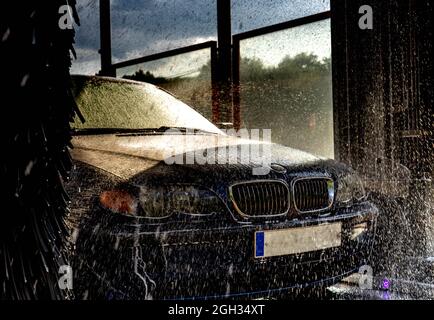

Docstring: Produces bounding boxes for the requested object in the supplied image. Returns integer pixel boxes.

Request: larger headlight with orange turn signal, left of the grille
[100,184,222,219]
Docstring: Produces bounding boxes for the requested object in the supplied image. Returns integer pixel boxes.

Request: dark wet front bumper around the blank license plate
[75,202,378,299]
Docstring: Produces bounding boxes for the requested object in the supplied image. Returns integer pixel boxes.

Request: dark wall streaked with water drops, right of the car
[331,0,434,280]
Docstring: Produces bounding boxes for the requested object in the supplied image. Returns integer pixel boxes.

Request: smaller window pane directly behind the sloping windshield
[116,49,212,119]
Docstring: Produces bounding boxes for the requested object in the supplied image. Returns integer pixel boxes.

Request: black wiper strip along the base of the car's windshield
[72,126,217,136]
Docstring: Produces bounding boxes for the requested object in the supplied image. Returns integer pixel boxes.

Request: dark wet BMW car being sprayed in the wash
[67,76,378,300]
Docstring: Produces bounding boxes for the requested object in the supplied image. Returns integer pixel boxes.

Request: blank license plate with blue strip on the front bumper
[254,222,342,258]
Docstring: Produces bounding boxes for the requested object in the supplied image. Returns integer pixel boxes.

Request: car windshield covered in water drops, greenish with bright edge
[72,76,222,133]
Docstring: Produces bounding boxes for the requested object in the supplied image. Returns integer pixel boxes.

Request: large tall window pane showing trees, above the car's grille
[240,19,334,158]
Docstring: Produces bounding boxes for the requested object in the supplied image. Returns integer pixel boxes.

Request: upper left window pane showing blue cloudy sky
[111,0,217,63]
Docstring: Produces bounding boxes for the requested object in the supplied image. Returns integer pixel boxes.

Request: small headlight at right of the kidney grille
[336,173,366,205]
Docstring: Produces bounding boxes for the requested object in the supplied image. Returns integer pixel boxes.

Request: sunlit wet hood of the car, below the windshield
[71,134,325,179]
